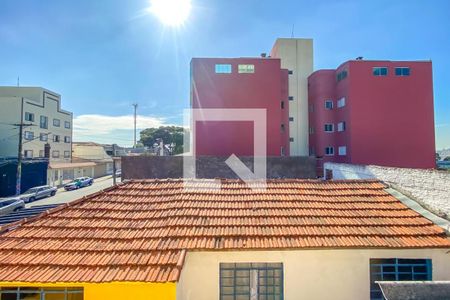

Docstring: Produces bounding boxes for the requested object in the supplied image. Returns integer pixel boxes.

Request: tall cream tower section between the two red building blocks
[270,38,313,156]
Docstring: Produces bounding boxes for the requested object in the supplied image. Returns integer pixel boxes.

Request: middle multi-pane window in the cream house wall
[219,263,284,300]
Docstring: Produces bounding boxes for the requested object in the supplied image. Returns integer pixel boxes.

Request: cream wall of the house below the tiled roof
[177,249,450,300]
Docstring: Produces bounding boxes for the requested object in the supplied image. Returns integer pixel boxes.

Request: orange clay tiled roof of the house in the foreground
[0,179,450,282]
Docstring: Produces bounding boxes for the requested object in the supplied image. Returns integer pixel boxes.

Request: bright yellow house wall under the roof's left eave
[0,282,176,300]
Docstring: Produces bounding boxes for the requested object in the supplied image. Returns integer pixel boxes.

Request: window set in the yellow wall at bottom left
[0,287,83,300]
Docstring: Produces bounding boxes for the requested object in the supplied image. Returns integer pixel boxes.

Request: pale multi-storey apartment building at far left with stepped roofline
[0,87,73,163]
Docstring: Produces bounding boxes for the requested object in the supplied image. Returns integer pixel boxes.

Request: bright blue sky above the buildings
[0,0,450,149]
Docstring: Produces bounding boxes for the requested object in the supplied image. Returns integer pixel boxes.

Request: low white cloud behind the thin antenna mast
[73,115,171,146]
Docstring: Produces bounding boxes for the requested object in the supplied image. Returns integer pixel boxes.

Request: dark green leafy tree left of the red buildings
[139,126,184,154]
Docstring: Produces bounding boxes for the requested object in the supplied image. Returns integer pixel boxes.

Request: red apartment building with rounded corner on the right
[308,60,435,169]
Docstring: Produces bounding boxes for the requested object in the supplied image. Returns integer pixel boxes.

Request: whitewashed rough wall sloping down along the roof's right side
[324,163,450,219]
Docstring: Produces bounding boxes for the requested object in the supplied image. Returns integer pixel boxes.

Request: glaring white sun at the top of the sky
[150,0,192,26]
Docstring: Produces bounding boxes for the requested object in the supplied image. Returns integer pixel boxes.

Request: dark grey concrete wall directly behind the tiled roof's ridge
[122,156,316,179]
